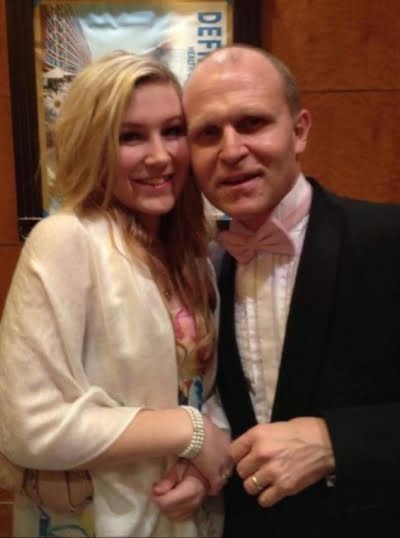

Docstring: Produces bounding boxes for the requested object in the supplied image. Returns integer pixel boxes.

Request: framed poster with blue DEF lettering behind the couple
[34,0,232,215]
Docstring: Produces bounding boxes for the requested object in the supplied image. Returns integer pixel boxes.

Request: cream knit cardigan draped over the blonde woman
[0,212,215,537]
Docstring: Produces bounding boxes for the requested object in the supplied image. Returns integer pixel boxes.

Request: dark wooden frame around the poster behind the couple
[6,0,261,241]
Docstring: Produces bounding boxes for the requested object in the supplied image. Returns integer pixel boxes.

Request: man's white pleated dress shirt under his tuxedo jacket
[235,174,311,423]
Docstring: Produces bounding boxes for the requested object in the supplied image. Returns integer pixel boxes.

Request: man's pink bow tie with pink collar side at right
[218,188,311,264]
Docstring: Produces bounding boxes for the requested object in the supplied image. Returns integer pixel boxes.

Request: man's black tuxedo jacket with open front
[217,178,400,536]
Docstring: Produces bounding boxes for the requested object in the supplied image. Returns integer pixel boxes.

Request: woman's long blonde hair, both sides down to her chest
[53,51,216,368]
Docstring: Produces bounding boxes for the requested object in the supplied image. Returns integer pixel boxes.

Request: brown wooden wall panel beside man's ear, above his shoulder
[302,91,400,202]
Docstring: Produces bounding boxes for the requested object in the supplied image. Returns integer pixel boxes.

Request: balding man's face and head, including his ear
[184,51,310,229]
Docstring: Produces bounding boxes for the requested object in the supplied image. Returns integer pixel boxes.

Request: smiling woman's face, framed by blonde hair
[113,82,189,235]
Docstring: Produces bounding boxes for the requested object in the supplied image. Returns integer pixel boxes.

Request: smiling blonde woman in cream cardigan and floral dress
[0,52,231,537]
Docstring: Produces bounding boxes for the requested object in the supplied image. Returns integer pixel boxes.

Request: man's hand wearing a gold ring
[231,417,335,507]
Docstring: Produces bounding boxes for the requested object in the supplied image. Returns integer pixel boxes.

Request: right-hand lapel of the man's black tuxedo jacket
[272,180,344,421]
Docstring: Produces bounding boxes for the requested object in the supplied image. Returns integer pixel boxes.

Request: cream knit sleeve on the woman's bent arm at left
[0,215,138,469]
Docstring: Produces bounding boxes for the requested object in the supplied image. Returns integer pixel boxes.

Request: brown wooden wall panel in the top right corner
[263,0,400,90]
